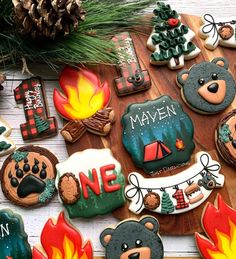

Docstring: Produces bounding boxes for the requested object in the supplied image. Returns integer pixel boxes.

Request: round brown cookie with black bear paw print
[0,146,58,207]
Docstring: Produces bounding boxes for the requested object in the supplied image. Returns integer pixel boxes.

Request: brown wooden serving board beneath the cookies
[67,15,236,238]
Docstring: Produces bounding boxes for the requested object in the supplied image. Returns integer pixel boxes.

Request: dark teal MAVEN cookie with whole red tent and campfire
[122,96,195,174]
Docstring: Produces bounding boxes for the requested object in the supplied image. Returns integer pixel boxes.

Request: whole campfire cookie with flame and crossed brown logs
[53,67,115,143]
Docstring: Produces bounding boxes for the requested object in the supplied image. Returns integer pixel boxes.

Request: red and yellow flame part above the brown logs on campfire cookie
[53,67,111,120]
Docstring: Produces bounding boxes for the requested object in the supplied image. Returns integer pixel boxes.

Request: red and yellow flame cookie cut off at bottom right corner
[195,194,236,259]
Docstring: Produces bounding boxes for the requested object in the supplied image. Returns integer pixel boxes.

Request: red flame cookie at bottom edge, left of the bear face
[32,212,93,259]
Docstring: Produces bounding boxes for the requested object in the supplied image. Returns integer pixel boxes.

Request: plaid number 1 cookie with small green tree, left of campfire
[14,77,57,140]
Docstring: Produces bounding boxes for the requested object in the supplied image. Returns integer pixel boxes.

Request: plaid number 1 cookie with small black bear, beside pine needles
[112,32,151,96]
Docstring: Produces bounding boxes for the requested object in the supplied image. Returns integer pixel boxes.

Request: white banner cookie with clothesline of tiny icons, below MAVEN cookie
[125,152,224,214]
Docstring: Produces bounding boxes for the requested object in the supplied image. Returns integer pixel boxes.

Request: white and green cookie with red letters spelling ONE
[56,149,125,218]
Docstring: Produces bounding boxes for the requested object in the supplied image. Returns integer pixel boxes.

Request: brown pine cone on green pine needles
[12,0,85,39]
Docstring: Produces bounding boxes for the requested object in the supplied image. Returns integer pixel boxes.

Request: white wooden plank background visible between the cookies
[0,0,236,257]
